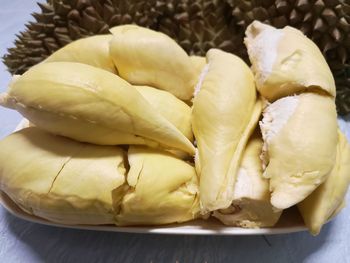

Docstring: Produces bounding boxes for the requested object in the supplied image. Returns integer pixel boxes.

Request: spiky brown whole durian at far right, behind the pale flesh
[225,0,350,114]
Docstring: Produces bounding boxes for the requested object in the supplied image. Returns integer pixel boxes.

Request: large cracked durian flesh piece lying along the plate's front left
[0,127,199,225]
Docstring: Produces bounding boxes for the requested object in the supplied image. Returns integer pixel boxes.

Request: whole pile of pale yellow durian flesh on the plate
[0,21,350,234]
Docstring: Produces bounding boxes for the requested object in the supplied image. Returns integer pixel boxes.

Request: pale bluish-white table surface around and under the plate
[0,0,350,263]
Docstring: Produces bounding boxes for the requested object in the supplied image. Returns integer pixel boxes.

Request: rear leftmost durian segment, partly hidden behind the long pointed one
[43,35,117,74]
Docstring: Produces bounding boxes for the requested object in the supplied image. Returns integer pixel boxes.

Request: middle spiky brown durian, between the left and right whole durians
[157,0,245,55]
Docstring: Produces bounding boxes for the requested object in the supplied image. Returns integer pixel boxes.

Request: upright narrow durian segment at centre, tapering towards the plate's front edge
[192,49,261,213]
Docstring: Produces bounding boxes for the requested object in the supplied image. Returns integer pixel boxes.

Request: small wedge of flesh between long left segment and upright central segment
[134,86,193,141]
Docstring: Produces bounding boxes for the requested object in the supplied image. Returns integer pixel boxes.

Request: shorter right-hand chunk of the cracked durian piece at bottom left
[116,146,199,225]
